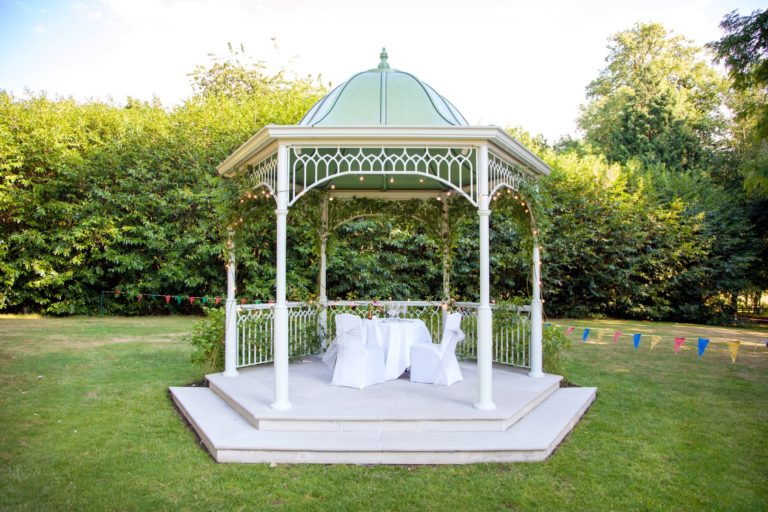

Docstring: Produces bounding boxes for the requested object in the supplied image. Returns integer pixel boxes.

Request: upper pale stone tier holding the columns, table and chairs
[207,362,561,432]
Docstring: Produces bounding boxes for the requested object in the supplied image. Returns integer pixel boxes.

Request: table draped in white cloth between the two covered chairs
[365,318,432,380]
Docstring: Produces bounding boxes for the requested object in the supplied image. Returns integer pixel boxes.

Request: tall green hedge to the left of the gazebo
[0,52,322,314]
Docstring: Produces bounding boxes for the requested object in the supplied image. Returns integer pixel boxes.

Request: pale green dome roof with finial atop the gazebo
[299,49,467,126]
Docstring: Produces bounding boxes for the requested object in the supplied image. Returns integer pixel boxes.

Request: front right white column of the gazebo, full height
[475,145,496,411]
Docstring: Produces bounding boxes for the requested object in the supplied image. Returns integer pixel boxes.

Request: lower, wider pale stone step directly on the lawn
[171,388,596,464]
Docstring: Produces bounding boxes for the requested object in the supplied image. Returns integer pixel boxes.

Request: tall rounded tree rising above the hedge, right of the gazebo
[578,23,724,170]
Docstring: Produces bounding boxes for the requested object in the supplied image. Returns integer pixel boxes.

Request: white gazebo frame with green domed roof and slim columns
[218,51,550,410]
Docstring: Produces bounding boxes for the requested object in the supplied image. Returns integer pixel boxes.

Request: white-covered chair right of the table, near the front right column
[411,313,464,386]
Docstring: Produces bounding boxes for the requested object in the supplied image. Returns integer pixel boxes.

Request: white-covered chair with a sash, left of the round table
[323,314,384,389]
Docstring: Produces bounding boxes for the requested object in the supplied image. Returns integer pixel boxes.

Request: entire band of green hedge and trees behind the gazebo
[0,28,768,321]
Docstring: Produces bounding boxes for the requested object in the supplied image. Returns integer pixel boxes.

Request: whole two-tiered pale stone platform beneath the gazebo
[171,357,596,464]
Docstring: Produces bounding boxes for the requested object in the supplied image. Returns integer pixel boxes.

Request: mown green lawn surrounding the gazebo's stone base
[0,317,768,510]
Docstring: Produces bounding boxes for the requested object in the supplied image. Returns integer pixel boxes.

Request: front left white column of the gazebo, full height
[271,144,291,410]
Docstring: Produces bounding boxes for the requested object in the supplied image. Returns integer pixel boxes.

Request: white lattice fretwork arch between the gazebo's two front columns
[289,147,477,205]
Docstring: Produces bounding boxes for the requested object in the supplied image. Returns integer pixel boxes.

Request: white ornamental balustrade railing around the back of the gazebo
[237,300,531,368]
